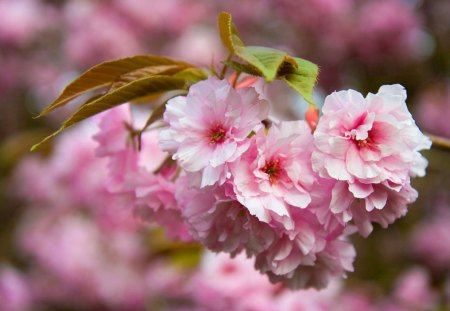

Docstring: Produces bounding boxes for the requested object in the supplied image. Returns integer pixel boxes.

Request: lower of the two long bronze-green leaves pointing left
[31,76,186,150]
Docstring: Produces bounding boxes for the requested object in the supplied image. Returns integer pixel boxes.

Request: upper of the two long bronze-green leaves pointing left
[38,55,193,117]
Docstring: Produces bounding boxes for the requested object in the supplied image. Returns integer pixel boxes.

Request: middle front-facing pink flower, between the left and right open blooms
[232,121,315,230]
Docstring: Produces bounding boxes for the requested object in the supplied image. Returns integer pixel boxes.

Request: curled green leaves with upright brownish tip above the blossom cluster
[219,12,319,105]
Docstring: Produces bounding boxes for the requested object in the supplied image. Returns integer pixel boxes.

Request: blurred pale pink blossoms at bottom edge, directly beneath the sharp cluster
[187,253,339,311]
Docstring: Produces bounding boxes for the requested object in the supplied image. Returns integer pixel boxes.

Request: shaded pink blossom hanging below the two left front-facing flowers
[176,176,277,255]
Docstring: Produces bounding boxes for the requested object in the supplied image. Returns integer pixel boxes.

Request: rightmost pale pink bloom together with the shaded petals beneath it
[312,85,431,235]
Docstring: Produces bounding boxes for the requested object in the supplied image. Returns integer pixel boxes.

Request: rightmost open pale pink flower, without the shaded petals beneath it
[313,85,431,184]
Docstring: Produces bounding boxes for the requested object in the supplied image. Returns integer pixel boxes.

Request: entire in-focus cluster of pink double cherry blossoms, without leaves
[95,77,431,288]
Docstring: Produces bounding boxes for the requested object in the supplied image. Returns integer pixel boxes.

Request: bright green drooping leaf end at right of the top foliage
[279,58,319,106]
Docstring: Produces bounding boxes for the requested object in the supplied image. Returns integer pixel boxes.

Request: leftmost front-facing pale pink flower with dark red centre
[159,77,268,187]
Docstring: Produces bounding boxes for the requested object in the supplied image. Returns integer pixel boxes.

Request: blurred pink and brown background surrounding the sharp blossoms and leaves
[0,0,450,311]
